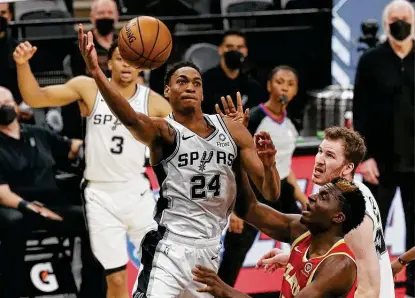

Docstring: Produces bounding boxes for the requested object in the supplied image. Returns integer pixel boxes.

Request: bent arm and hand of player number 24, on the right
[224,118,281,201]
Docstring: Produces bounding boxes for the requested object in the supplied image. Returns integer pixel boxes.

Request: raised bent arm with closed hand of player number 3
[13,41,93,108]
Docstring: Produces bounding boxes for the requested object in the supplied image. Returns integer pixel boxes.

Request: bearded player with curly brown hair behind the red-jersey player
[216,100,395,298]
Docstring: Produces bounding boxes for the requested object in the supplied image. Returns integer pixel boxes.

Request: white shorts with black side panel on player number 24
[133,227,221,298]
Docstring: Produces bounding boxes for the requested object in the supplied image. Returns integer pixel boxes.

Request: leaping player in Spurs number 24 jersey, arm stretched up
[78,25,280,298]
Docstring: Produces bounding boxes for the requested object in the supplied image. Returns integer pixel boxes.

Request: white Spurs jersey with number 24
[156,115,238,239]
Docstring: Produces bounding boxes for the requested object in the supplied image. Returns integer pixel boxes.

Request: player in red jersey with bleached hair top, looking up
[192,177,365,298]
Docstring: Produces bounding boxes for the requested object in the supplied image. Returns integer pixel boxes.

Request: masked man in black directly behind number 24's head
[202,31,268,114]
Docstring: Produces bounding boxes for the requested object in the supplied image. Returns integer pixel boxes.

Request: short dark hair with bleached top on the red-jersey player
[331,178,366,235]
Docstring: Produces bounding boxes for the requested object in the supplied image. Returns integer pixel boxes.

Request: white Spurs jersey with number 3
[84,85,150,182]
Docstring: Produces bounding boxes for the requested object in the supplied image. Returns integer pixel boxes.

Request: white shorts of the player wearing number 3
[84,178,157,272]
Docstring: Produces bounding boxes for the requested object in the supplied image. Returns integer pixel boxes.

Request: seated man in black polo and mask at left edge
[0,87,105,298]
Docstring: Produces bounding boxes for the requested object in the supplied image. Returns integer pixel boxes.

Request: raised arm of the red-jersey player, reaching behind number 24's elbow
[234,165,307,243]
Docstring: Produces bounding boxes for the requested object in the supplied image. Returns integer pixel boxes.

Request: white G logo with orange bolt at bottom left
[30,262,59,293]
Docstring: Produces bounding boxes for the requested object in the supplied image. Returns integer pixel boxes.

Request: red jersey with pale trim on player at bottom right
[280,232,357,298]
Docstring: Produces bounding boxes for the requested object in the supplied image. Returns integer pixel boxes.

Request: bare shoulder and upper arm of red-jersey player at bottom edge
[295,255,357,298]
